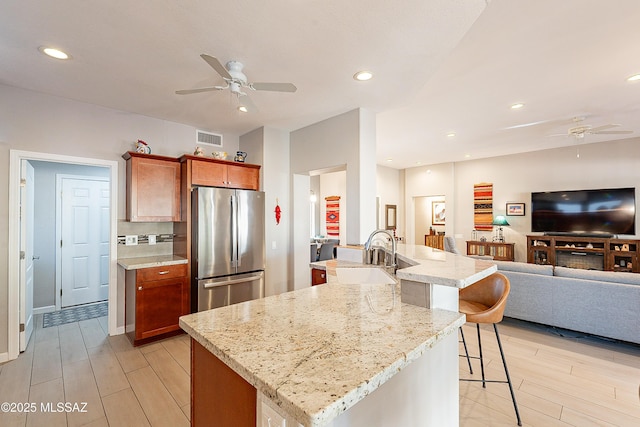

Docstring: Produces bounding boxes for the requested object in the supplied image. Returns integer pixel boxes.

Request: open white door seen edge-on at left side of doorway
[20,160,35,351]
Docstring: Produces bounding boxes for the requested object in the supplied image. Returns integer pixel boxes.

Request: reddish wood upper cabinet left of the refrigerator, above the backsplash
[122,151,180,222]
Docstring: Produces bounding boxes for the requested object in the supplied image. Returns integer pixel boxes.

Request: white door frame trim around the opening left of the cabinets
[7,150,119,360]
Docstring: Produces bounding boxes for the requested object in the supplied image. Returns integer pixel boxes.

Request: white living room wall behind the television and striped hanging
[405,138,640,261]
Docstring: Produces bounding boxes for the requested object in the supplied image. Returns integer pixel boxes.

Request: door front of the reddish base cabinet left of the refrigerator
[135,277,189,339]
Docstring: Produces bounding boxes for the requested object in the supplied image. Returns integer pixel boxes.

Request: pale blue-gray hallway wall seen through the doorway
[30,161,109,308]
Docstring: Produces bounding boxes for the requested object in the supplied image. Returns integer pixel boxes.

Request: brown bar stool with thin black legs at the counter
[458,273,522,426]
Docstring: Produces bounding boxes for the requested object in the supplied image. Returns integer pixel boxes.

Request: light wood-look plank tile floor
[0,316,640,427]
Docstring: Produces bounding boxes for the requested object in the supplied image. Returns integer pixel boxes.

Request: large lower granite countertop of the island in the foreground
[180,283,465,427]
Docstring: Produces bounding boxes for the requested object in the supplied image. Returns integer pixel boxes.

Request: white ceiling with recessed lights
[0,0,640,168]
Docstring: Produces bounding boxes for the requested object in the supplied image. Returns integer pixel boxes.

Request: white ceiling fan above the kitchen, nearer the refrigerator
[176,53,298,112]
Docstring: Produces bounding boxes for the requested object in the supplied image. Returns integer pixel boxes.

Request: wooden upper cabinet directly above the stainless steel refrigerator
[181,156,260,190]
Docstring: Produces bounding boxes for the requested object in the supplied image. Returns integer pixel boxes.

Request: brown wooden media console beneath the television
[527,235,640,273]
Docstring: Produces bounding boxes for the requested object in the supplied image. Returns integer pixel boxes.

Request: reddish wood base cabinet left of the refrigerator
[125,264,190,345]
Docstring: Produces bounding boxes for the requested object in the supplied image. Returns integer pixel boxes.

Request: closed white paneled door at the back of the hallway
[59,177,110,307]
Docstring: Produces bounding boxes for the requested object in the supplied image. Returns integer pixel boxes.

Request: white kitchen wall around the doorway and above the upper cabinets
[0,85,238,354]
